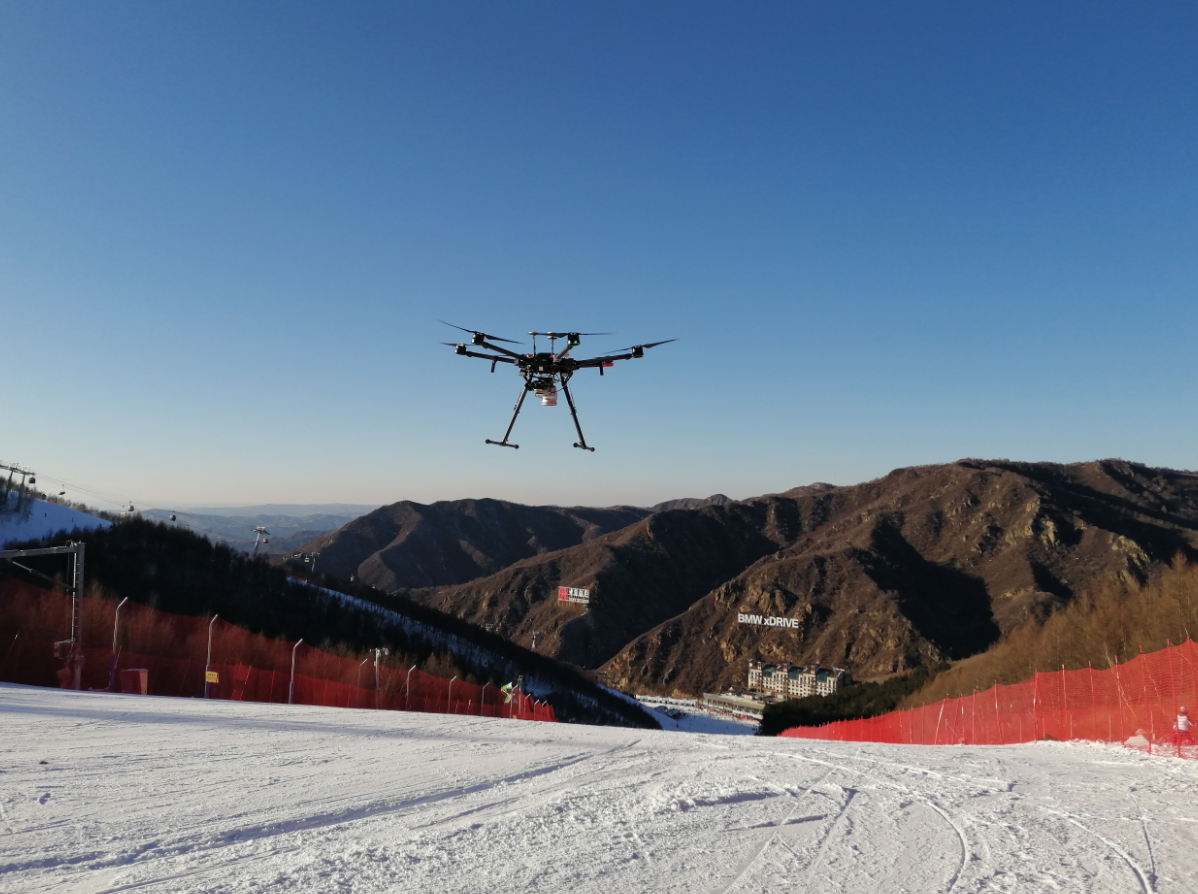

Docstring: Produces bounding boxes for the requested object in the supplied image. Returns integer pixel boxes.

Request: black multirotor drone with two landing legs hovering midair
[440,320,678,453]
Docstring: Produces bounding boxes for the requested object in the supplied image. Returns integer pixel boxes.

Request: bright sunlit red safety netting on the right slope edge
[781,640,1198,757]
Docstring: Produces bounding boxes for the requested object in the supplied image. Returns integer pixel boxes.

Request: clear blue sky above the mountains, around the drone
[0,0,1198,506]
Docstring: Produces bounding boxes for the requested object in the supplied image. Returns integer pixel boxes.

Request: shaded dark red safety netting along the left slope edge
[0,580,557,723]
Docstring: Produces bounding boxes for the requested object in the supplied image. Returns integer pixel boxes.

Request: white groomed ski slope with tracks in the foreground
[0,685,1198,894]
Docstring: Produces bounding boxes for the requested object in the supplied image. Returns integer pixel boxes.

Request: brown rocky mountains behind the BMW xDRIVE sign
[301,460,1198,695]
